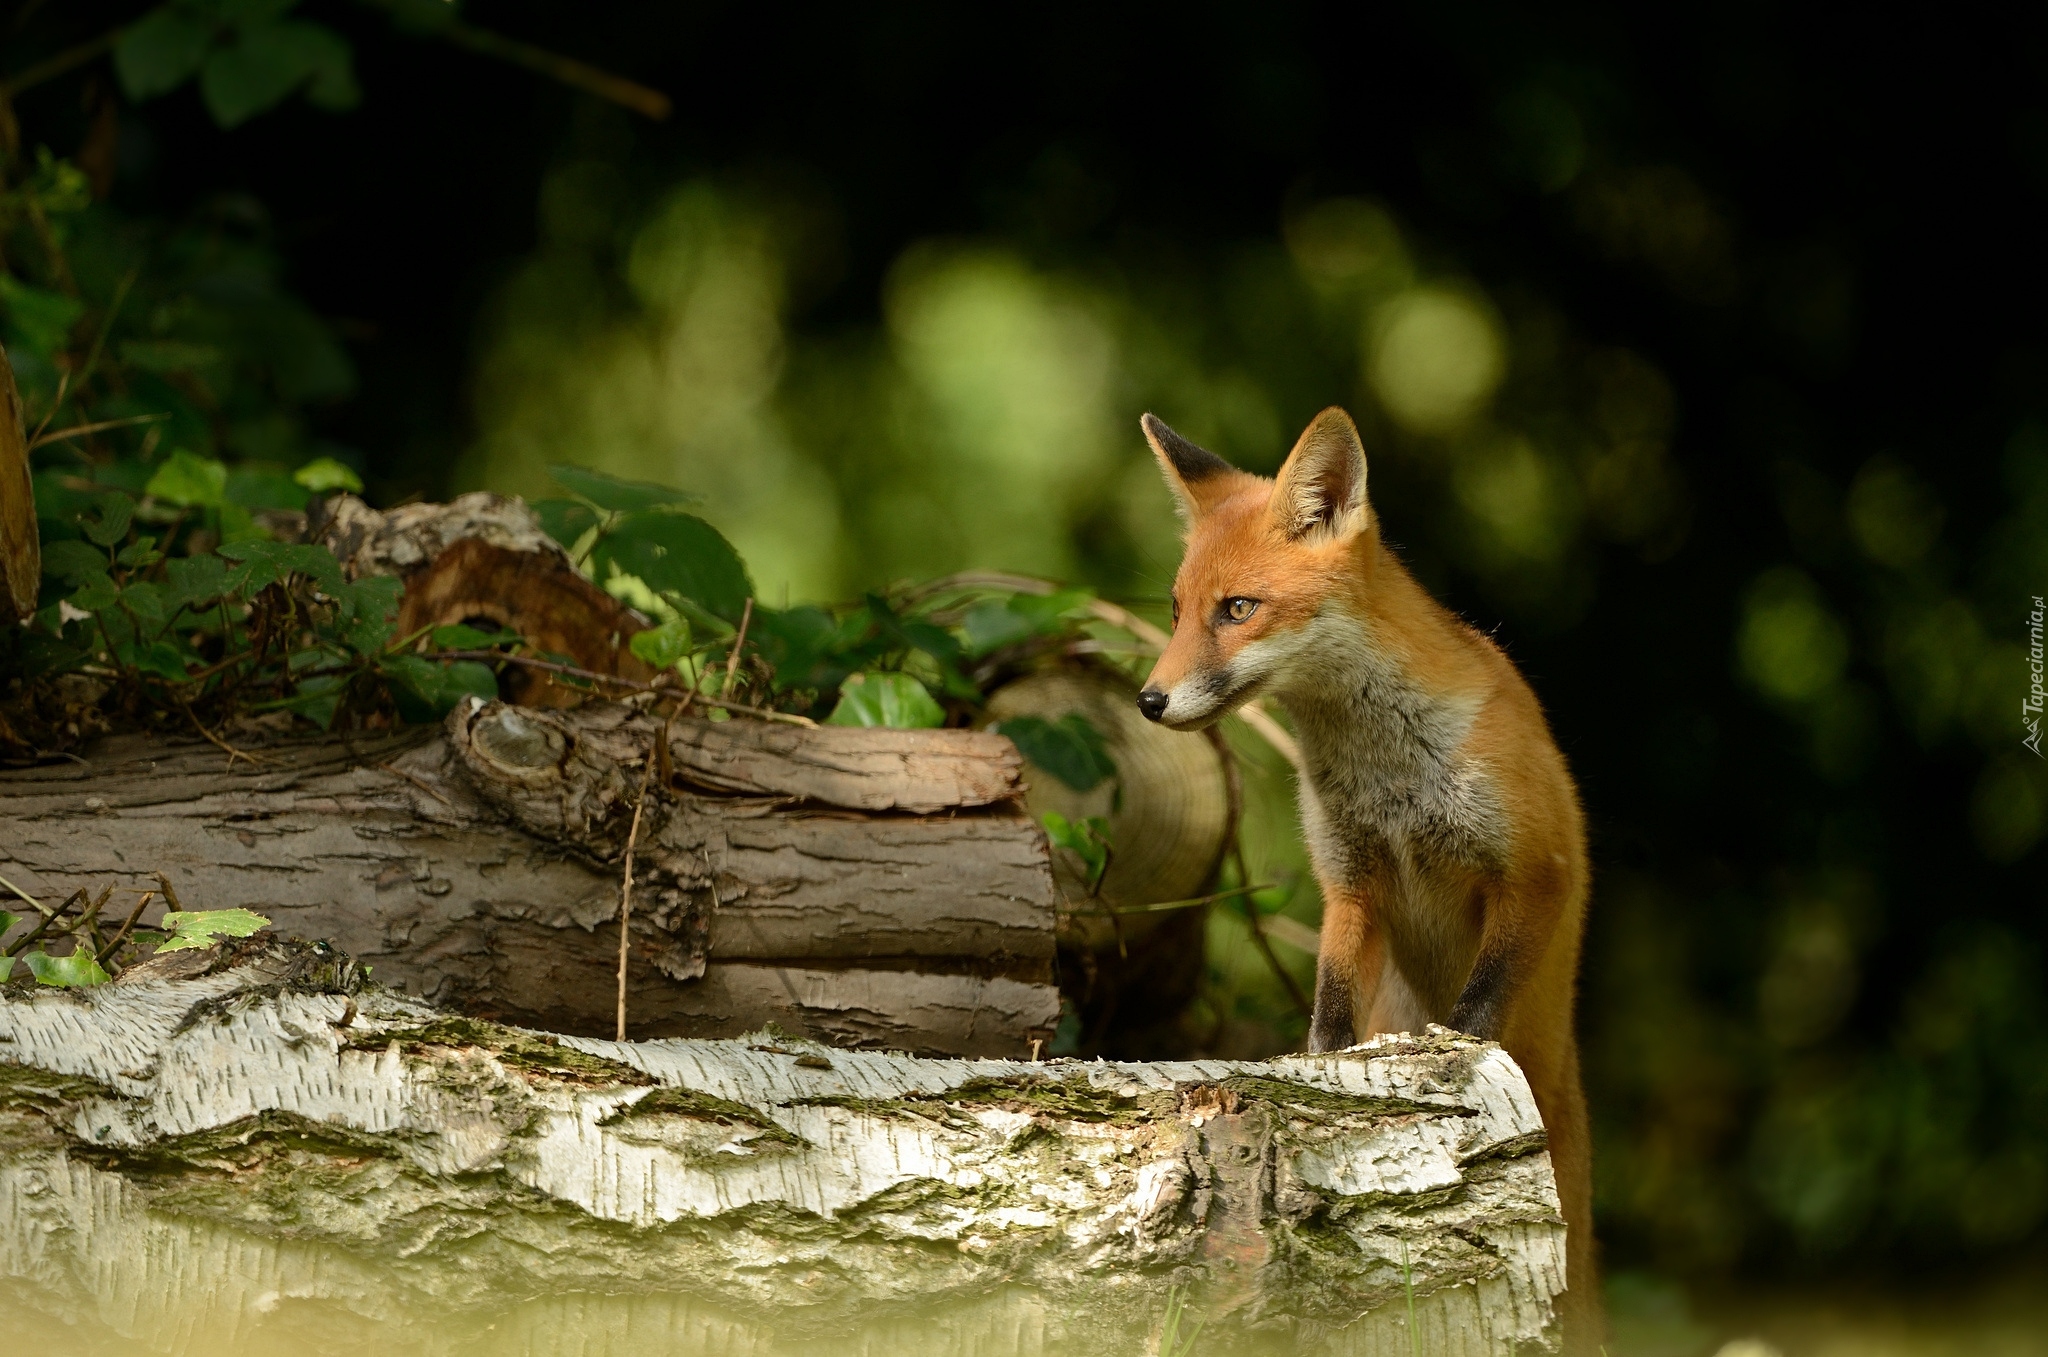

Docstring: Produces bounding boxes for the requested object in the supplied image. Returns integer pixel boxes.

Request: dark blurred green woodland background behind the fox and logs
[0,0,2048,1353]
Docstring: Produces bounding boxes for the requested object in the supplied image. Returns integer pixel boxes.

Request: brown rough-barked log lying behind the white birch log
[0,702,1059,1054]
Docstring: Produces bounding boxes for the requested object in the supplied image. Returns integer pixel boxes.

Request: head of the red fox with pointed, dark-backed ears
[1139,405,1378,731]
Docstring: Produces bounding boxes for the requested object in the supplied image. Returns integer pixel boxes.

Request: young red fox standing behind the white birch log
[1139,407,1602,1353]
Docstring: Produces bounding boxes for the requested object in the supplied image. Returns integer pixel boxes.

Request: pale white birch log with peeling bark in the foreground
[0,944,1565,1357]
